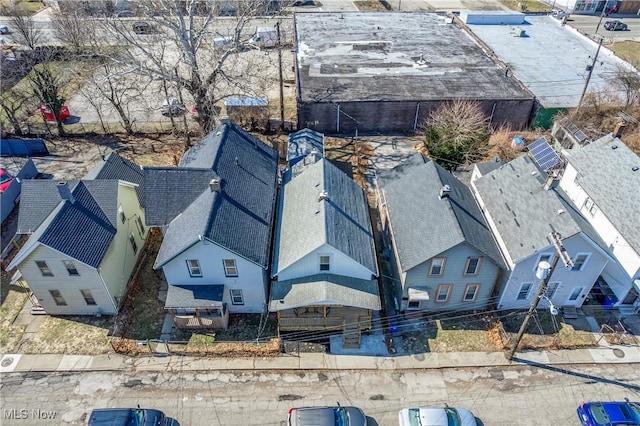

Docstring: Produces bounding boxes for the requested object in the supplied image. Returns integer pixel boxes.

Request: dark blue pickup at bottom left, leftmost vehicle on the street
[87,408,174,426]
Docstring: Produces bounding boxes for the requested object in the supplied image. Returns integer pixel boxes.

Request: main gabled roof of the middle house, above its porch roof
[272,158,378,276]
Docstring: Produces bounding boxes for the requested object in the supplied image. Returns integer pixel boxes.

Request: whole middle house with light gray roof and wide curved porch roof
[269,158,380,345]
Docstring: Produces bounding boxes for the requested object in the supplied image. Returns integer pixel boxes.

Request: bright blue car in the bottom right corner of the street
[577,401,640,426]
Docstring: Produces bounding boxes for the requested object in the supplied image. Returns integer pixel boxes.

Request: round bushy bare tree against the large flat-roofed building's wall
[422,100,489,170]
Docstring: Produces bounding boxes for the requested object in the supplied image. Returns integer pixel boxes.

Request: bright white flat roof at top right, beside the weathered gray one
[468,16,629,108]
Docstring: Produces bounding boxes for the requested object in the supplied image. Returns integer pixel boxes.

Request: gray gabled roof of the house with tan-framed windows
[378,154,504,271]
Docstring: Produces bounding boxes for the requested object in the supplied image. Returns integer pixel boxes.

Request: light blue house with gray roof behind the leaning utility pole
[471,155,610,309]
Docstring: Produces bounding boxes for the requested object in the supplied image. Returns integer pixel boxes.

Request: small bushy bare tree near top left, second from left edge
[51,9,96,53]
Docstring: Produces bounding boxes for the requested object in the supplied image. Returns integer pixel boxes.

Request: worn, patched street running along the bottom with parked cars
[0,364,640,426]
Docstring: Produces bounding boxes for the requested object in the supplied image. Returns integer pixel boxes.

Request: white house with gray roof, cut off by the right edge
[560,135,640,309]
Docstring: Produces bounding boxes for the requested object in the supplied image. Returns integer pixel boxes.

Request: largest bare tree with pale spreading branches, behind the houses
[101,0,276,133]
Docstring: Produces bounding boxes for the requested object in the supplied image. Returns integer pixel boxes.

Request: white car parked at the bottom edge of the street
[398,407,478,426]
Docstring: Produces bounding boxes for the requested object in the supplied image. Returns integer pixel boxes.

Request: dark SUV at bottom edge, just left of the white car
[287,405,367,426]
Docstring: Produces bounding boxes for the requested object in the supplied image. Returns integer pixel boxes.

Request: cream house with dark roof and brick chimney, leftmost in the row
[8,153,148,315]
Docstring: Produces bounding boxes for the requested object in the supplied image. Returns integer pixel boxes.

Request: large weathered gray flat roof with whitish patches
[295,12,532,102]
